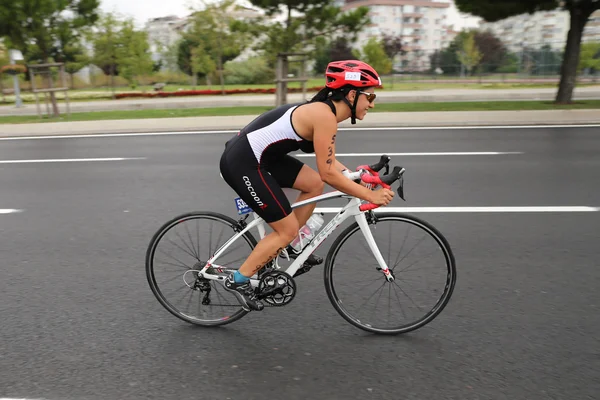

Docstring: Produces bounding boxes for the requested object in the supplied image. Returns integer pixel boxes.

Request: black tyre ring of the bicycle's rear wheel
[146,211,257,327]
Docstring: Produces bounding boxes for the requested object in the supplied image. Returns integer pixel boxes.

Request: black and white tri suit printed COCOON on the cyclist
[220,103,315,222]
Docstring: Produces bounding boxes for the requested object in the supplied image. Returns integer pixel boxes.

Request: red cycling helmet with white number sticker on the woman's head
[325,60,381,89]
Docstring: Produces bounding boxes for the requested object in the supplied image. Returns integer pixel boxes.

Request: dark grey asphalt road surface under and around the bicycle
[0,128,600,400]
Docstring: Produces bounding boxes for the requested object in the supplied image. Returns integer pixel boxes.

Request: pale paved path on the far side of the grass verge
[0,85,600,116]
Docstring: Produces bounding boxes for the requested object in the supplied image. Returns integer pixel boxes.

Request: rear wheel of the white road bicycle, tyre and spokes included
[146,212,257,326]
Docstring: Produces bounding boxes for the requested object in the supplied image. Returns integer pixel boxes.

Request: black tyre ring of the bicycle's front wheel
[324,212,456,335]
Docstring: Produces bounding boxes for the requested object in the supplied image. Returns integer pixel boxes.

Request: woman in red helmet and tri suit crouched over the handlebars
[220,60,394,311]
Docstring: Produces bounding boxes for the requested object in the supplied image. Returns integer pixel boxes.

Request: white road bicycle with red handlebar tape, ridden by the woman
[146,154,456,334]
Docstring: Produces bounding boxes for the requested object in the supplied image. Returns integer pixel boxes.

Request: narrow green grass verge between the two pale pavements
[0,100,600,124]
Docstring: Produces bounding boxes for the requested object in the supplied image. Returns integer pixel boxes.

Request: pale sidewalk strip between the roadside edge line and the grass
[0,109,600,137]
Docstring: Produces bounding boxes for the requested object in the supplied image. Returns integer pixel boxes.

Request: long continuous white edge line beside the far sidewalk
[0,124,600,140]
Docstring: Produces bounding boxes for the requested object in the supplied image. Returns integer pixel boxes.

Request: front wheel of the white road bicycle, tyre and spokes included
[324,213,456,334]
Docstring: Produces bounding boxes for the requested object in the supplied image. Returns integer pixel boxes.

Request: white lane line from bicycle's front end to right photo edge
[315,206,600,214]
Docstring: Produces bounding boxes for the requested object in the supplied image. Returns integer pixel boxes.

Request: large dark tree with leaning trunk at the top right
[455,0,600,104]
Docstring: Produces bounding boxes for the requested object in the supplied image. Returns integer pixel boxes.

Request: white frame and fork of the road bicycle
[199,171,393,287]
